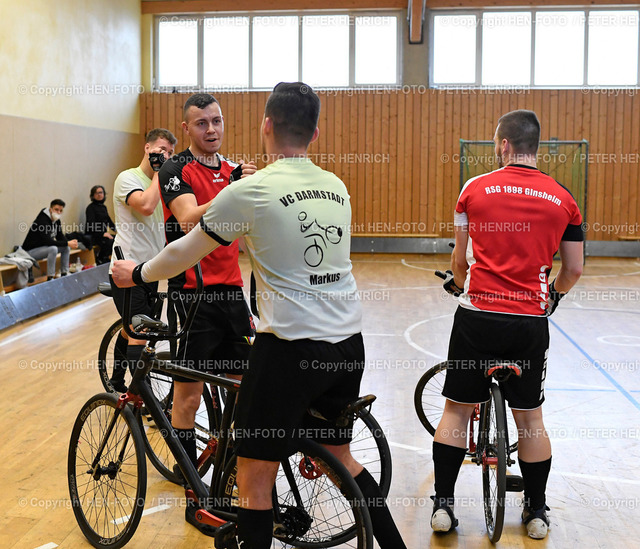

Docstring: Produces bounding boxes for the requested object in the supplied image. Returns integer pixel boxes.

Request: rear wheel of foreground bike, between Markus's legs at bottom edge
[216,439,373,549]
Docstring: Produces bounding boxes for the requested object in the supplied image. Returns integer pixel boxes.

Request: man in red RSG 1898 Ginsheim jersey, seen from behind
[431,110,584,539]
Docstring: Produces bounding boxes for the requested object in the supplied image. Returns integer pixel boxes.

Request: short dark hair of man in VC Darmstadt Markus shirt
[264,82,320,147]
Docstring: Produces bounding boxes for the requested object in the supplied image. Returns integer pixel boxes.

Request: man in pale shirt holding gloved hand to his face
[109,128,178,392]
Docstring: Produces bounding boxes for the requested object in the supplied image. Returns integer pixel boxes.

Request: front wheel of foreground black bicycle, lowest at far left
[67,393,147,549]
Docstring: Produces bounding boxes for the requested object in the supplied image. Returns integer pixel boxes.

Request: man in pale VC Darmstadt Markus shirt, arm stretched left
[114,82,405,549]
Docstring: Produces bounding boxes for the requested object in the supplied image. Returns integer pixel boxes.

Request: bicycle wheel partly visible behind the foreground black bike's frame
[138,382,222,484]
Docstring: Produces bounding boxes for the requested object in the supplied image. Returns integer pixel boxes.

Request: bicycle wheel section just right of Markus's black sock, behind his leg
[350,410,393,497]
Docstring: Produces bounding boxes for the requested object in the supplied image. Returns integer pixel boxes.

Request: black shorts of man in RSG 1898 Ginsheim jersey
[442,307,549,410]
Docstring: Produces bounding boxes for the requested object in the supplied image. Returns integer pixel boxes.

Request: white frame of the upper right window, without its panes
[428,4,640,89]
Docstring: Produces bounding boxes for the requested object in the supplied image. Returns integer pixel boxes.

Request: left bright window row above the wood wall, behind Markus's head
[154,12,402,89]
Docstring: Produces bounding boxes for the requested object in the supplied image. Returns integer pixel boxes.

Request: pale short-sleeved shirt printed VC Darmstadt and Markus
[203,158,362,343]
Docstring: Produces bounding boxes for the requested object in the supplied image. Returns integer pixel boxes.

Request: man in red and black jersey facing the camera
[159,93,256,535]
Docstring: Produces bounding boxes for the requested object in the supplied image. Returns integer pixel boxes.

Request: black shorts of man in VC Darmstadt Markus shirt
[234,333,364,461]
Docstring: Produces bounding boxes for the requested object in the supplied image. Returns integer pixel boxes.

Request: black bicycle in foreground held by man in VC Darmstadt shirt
[67,256,372,548]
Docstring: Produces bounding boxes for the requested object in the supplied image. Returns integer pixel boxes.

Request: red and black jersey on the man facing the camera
[158,149,242,289]
